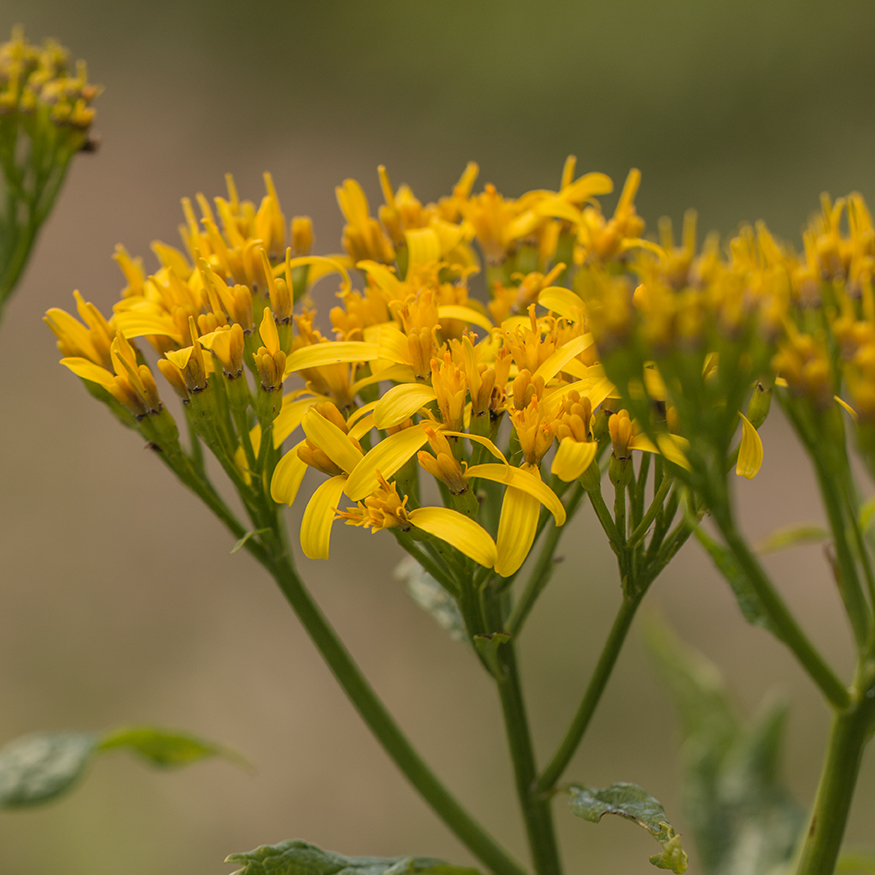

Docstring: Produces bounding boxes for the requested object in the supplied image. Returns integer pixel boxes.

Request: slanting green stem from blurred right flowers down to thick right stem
[712,503,851,709]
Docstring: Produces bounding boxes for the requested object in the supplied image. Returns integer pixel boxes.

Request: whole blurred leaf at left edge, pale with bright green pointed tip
[0,726,244,808]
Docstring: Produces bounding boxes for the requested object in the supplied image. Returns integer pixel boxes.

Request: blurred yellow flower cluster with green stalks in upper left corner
[0,28,100,318]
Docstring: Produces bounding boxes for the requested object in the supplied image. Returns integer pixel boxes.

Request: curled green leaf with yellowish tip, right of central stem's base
[568,782,689,873]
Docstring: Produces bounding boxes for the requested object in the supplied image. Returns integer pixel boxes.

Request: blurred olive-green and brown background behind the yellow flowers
[0,0,875,875]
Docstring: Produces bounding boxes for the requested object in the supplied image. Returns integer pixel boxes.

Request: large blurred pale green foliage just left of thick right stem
[647,623,804,875]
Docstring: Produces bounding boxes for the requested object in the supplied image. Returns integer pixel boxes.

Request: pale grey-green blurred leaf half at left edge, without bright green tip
[0,732,97,808]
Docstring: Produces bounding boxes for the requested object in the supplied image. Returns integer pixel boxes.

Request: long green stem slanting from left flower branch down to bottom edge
[266,551,525,875]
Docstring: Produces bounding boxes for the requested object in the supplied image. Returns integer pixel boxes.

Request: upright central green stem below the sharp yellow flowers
[486,590,562,875]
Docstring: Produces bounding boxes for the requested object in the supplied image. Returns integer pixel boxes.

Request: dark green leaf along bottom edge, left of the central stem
[225,839,479,875]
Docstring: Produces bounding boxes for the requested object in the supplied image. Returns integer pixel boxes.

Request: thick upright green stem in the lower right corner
[795,676,875,875]
